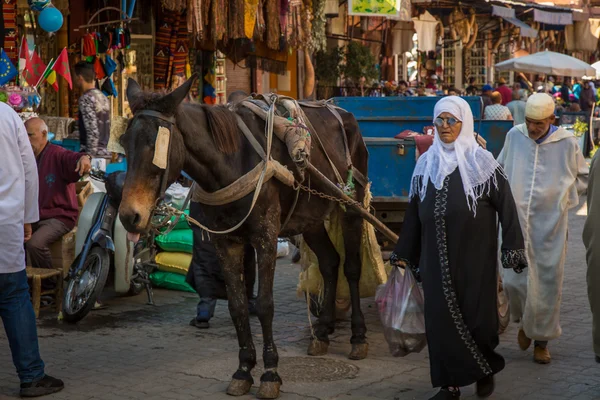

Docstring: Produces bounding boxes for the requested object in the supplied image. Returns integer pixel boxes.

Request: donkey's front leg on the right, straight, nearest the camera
[256,236,282,399]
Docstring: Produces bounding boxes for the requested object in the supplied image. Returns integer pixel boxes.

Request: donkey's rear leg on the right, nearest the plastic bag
[343,214,369,360]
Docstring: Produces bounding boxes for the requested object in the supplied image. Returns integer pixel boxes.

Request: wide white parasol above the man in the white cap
[496,50,596,78]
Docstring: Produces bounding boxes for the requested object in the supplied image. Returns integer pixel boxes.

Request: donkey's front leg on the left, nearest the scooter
[214,238,256,396]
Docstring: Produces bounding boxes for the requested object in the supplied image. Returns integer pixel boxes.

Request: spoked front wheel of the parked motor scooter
[63,247,110,323]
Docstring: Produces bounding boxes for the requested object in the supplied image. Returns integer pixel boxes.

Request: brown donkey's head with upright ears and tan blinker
[119,76,195,236]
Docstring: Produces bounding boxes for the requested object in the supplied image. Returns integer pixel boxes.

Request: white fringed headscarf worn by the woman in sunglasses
[410,96,504,214]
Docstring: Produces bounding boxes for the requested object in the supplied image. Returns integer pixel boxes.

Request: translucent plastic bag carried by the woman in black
[375,267,427,357]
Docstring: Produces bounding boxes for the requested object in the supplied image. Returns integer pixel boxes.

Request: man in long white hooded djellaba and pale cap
[498,93,589,364]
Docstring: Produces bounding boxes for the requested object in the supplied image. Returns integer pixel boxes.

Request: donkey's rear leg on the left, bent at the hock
[303,225,340,356]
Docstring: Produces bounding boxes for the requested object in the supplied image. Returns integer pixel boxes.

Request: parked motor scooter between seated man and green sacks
[63,170,156,322]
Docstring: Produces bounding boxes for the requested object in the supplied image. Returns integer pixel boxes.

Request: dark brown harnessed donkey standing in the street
[119,77,368,399]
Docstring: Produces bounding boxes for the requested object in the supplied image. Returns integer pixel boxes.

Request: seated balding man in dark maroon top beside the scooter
[25,118,91,268]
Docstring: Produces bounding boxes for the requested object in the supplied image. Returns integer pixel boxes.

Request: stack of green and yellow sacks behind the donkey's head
[150,210,196,293]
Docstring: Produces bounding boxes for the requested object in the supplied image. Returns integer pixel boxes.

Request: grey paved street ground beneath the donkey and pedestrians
[0,198,600,400]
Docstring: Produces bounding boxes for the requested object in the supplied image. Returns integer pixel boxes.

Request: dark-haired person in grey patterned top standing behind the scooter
[74,61,110,157]
